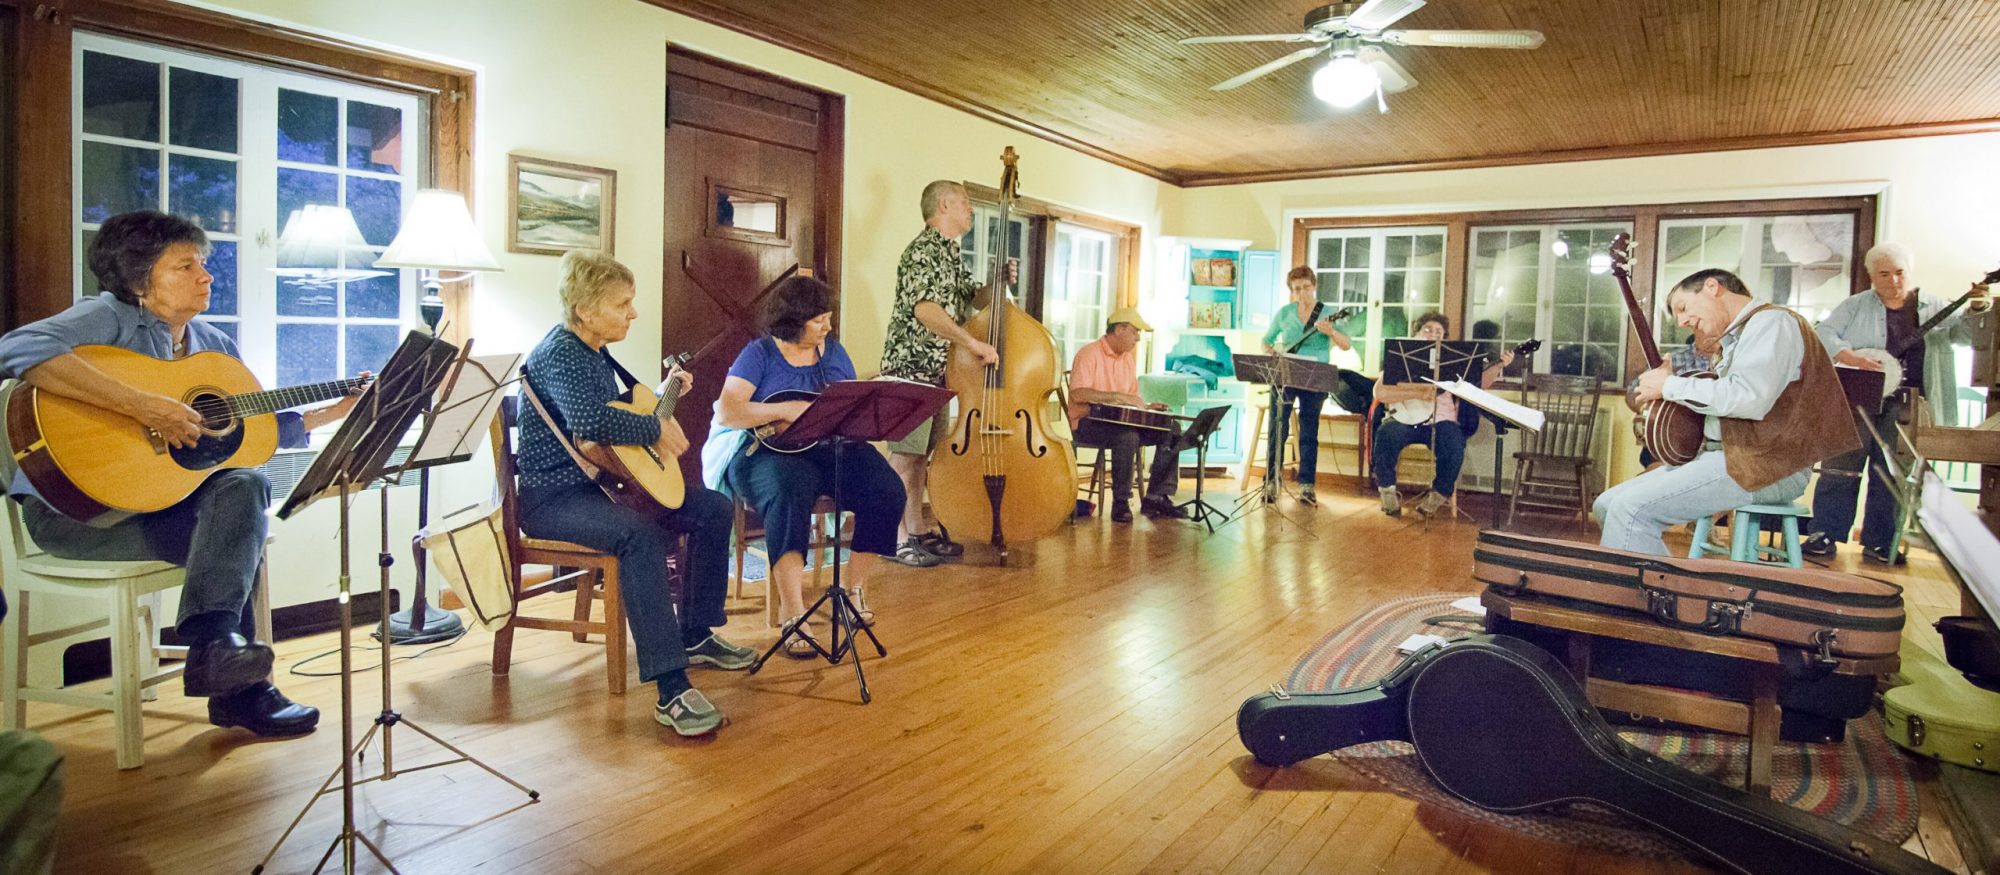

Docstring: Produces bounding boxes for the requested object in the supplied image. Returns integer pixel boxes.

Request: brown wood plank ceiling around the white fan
[646,0,2000,186]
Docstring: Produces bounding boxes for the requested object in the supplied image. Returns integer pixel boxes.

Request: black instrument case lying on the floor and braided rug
[1236,635,1946,875]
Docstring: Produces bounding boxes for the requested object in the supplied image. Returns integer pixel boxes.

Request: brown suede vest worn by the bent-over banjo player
[1722,304,1862,491]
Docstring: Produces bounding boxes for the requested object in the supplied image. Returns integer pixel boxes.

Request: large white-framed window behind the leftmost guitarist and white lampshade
[72,34,422,386]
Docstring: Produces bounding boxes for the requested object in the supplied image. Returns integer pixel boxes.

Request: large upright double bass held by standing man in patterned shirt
[930,146,1076,565]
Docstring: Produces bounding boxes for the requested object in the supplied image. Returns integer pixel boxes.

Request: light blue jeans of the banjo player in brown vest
[1590,447,1812,555]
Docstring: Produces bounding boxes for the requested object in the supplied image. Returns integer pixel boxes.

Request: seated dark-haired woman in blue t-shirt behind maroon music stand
[704,276,904,659]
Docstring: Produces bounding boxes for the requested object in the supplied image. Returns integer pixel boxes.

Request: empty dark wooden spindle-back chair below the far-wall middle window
[1506,374,1602,525]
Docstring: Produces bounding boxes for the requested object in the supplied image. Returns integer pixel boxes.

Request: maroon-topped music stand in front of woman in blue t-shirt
[750,380,954,705]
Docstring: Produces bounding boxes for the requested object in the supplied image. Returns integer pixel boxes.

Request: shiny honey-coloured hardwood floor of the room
[30,489,1958,873]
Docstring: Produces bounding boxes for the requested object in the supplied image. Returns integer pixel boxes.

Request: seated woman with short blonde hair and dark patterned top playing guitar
[518,250,756,735]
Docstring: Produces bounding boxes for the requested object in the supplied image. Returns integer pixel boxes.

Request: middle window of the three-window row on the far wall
[1466,222,1632,384]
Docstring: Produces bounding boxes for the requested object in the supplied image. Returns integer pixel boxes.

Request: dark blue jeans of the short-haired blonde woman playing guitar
[520,483,732,681]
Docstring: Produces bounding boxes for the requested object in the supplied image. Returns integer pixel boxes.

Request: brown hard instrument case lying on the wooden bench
[1472,531,1904,663]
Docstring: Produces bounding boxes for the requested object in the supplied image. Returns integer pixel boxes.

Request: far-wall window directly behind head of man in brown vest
[1654,214,1856,352]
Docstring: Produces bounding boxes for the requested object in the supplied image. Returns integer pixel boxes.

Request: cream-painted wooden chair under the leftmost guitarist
[0,499,270,769]
